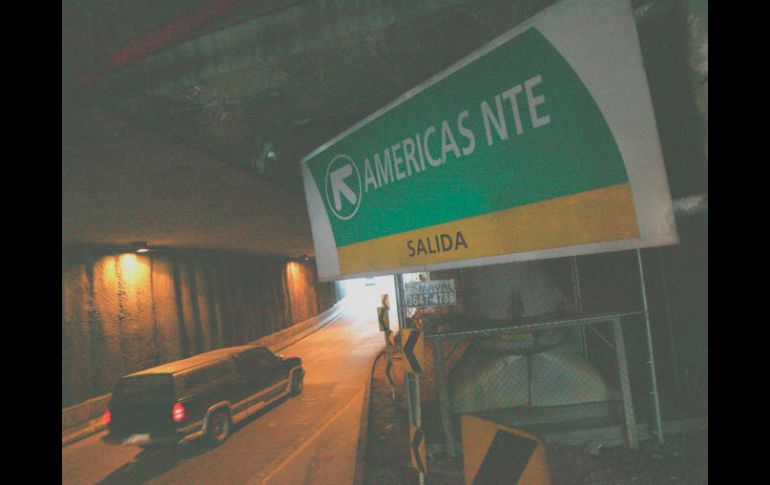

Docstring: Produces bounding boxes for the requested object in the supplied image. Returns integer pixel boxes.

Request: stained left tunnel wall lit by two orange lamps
[62,247,334,407]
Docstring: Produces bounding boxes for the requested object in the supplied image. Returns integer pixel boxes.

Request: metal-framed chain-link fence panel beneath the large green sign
[424,313,638,448]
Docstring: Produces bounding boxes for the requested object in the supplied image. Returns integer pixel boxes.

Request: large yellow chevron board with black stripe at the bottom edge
[460,414,551,485]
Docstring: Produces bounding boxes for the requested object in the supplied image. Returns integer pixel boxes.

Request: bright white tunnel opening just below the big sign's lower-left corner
[338,276,398,330]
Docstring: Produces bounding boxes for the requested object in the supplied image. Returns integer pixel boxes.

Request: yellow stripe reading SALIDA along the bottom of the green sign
[337,183,639,273]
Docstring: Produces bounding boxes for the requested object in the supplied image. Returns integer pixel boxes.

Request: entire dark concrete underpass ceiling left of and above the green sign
[62,0,676,255]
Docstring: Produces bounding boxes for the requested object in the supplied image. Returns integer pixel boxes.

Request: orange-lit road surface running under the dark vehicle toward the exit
[62,309,384,484]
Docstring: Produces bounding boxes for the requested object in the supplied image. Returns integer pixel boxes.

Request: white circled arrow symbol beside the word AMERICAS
[326,155,362,221]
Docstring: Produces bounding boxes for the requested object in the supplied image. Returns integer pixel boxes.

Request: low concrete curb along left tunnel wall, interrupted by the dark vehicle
[61,298,346,447]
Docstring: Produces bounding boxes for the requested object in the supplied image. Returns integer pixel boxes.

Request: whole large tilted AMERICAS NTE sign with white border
[302,0,677,280]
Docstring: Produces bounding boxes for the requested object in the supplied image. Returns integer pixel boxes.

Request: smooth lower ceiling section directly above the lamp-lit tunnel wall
[62,107,312,256]
